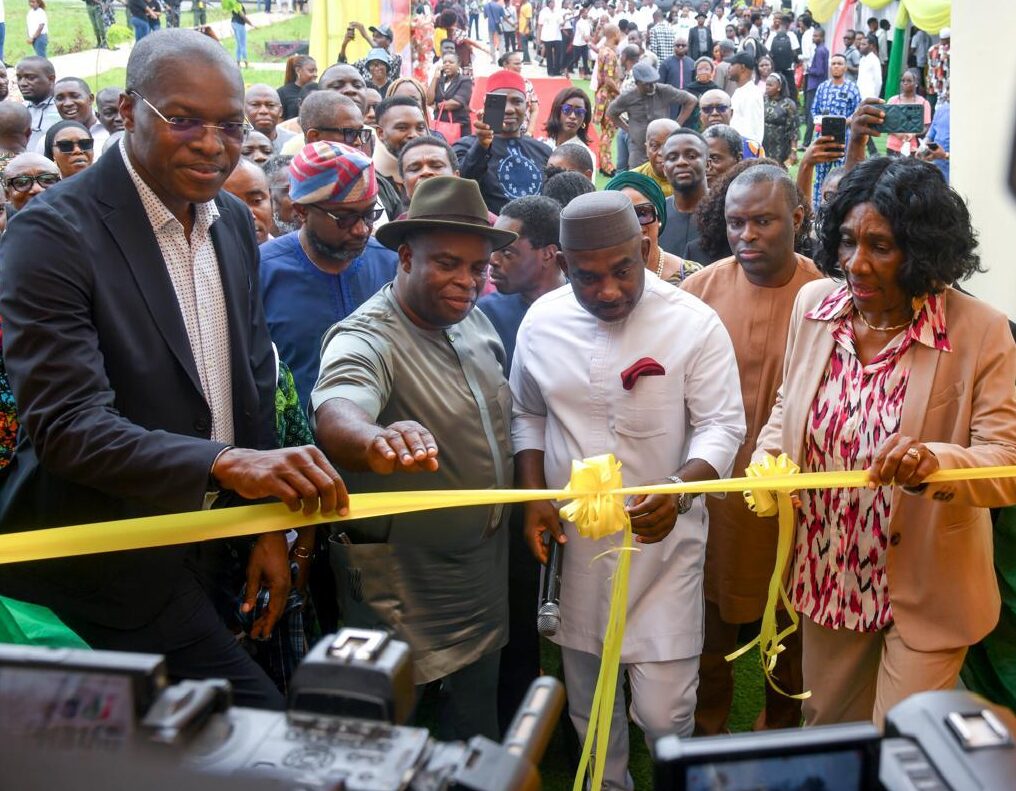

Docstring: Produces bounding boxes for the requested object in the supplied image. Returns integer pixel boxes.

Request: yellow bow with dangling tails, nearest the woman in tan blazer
[724,453,808,701]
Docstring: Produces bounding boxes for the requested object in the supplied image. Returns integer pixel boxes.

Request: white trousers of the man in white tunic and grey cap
[561,648,698,791]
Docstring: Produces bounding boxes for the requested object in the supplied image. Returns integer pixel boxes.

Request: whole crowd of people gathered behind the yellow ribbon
[0,0,1016,789]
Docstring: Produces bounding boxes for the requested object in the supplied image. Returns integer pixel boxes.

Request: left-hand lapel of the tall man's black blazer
[99,154,203,400]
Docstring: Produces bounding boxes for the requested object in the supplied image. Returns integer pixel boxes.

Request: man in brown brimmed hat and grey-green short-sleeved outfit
[311,176,515,739]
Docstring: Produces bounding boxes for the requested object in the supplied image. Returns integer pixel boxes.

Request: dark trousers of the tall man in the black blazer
[61,572,284,710]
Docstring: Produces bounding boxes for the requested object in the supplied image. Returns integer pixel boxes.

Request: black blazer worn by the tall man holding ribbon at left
[0,149,275,629]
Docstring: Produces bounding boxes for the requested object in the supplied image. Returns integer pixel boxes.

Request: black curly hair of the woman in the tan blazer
[815,156,983,296]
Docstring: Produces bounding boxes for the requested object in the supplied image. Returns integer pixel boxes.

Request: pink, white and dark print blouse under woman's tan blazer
[792,285,952,632]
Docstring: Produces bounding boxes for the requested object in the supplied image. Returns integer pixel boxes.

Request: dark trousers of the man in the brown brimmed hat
[417,651,501,741]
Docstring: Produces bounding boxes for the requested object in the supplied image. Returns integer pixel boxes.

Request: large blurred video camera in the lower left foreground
[0,629,564,791]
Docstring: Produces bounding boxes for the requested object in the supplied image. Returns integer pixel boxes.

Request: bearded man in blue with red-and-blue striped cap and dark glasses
[261,140,397,406]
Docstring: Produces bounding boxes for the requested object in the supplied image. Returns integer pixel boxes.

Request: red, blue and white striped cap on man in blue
[290,140,378,204]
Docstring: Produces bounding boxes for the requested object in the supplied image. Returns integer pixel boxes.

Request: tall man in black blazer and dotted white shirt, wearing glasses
[0,29,347,707]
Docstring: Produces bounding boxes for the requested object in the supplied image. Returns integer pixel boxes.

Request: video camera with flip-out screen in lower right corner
[653,690,1016,791]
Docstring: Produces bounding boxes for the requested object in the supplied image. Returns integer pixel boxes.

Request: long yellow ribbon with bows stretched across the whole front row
[0,455,1016,791]
